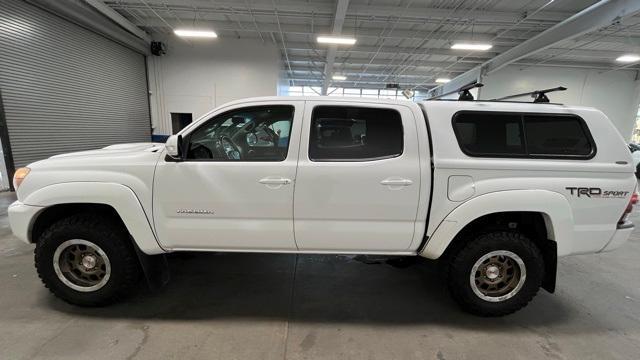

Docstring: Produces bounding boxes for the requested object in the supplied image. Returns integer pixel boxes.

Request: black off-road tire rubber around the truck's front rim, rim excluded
[34,214,141,307]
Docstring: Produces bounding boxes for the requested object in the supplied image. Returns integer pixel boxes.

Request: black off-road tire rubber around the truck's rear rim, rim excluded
[446,231,544,317]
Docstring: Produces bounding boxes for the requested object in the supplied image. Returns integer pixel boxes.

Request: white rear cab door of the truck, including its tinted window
[294,101,421,252]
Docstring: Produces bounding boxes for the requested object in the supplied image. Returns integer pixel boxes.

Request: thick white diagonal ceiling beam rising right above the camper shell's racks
[430,0,640,95]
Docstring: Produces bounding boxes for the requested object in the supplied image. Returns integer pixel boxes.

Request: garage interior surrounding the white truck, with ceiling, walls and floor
[0,0,640,360]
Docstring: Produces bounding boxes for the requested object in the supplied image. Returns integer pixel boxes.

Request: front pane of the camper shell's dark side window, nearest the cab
[455,113,525,155]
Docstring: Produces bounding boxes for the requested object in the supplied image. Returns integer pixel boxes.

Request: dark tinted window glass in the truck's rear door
[309,106,403,161]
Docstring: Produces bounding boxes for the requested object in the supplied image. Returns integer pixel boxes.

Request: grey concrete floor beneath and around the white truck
[0,193,640,360]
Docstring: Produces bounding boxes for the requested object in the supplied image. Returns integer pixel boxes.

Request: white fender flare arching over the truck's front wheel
[23,182,165,255]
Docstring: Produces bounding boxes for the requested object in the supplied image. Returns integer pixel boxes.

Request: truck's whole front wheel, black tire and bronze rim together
[35,215,140,306]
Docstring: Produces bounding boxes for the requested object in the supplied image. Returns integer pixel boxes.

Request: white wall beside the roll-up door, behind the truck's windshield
[148,36,281,135]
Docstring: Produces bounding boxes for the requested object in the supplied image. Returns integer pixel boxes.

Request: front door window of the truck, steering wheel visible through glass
[187,105,294,161]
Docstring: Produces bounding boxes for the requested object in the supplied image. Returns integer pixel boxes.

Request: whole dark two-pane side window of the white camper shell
[453,112,596,159]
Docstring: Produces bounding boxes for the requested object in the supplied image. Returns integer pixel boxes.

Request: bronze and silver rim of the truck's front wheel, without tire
[53,239,111,292]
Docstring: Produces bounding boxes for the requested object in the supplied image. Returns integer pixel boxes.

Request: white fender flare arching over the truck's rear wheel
[419,190,573,259]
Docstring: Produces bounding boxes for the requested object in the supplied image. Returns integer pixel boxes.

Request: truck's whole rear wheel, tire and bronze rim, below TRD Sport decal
[447,232,544,316]
